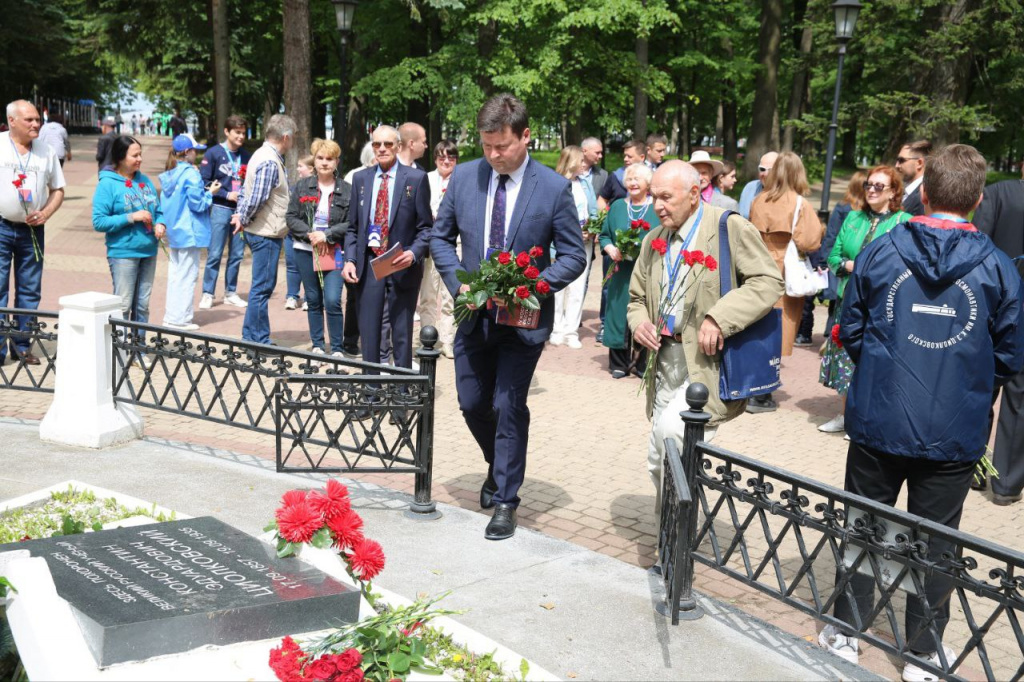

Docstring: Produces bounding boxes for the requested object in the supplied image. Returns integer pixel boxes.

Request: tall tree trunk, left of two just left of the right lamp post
[741,0,782,180]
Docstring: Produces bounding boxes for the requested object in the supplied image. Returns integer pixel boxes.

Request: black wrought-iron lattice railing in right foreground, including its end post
[659,384,1024,680]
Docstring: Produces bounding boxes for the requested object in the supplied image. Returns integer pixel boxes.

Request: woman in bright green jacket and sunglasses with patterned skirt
[818,166,911,433]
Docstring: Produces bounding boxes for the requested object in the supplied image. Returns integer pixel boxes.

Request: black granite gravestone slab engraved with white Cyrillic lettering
[0,516,359,667]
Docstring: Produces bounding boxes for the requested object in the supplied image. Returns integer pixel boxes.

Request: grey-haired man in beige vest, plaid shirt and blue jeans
[231,114,296,343]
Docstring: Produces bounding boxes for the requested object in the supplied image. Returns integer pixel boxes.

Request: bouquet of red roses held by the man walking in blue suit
[455,246,551,327]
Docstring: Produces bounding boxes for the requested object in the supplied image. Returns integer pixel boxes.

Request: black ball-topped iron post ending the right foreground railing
[679,383,711,620]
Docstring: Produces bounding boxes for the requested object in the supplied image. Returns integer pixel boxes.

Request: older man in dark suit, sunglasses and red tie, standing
[342,126,432,368]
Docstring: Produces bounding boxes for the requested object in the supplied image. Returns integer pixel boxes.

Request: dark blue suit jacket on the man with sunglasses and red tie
[345,162,433,289]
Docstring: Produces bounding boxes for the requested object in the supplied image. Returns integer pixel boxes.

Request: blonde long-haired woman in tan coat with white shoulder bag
[746,152,824,413]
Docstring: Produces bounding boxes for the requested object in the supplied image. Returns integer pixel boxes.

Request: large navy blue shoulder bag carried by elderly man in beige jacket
[718,211,782,400]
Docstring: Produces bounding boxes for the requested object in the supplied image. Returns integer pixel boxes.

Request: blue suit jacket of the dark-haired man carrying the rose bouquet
[430,159,587,344]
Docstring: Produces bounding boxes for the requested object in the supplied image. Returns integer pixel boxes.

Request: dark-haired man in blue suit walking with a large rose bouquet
[430,94,587,540]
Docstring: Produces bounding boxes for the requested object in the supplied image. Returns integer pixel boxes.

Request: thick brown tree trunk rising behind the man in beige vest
[283,0,312,168]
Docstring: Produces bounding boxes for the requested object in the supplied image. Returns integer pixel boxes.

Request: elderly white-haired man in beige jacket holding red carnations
[627,161,785,509]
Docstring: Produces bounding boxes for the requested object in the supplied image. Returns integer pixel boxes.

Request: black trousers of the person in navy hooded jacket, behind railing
[835,442,975,654]
